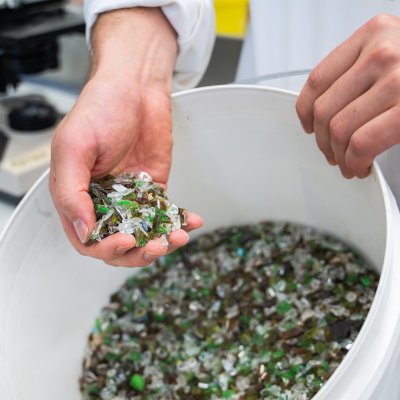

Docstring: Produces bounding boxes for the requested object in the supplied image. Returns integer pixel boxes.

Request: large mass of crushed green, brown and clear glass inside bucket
[80,222,378,400]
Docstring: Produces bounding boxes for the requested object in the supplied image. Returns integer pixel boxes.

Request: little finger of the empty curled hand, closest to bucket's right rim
[345,106,400,178]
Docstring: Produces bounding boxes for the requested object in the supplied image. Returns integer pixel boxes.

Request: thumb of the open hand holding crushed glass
[49,138,96,245]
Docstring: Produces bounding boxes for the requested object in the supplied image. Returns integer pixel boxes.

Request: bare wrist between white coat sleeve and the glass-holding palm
[91,7,178,93]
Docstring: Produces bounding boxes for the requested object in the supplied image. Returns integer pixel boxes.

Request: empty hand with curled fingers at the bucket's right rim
[296,15,400,178]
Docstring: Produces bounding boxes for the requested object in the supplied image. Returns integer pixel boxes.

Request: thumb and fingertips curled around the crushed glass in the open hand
[50,132,203,267]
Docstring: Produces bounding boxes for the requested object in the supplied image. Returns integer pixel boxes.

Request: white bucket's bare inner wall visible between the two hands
[169,87,386,270]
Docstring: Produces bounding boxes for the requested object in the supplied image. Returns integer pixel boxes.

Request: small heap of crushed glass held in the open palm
[88,172,187,247]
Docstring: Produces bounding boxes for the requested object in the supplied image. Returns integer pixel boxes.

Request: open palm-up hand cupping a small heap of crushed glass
[50,7,202,266]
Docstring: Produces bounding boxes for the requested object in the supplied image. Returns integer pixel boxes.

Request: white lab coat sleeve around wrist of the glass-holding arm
[84,0,215,90]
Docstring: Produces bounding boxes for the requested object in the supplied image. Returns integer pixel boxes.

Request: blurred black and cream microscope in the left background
[0,0,85,203]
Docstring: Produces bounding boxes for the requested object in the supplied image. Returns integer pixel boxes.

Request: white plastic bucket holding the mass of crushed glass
[0,86,400,400]
